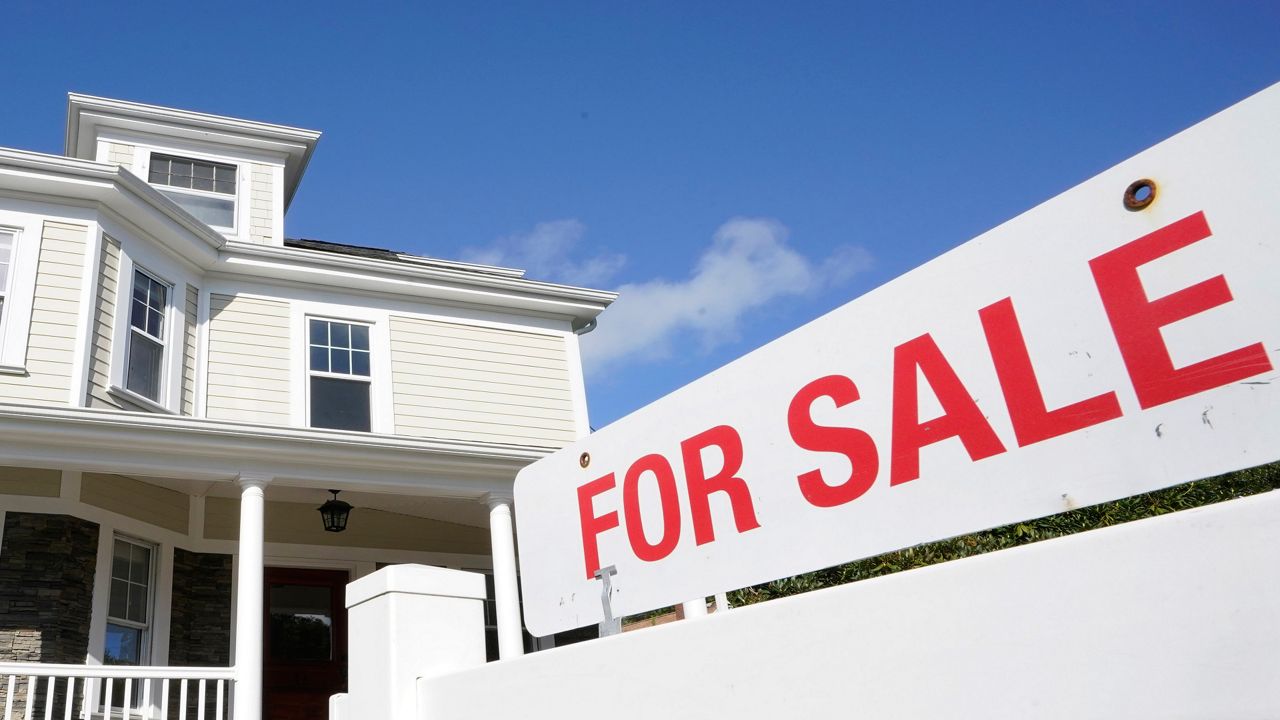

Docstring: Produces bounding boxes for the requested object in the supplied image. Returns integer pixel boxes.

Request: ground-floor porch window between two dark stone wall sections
[104,538,152,665]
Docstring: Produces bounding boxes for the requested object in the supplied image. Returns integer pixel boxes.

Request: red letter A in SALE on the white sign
[888,333,1005,486]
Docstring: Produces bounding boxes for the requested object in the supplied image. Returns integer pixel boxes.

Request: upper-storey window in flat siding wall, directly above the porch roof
[307,318,370,432]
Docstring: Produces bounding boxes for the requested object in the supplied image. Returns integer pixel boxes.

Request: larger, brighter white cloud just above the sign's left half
[582,218,870,374]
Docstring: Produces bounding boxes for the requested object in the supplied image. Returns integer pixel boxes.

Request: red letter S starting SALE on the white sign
[787,375,879,507]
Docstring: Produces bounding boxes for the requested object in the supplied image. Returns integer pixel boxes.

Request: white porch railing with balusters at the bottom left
[0,662,236,720]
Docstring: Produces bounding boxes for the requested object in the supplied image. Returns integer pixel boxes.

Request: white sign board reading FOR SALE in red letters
[516,86,1280,635]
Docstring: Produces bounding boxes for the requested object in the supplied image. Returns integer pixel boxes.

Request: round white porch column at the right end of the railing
[234,473,271,720]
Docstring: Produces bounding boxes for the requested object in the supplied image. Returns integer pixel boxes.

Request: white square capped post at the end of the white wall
[348,565,486,720]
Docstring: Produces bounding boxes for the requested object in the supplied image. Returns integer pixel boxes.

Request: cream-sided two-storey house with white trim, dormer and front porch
[0,94,614,720]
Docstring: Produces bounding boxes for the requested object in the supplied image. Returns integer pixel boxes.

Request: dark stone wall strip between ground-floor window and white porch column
[169,548,232,667]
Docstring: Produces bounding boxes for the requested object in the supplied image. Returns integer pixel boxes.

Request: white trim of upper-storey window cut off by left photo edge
[0,211,45,374]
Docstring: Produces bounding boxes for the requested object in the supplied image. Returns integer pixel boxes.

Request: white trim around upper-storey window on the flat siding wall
[291,299,396,434]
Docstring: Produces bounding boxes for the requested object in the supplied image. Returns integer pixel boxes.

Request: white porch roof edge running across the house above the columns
[0,405,552,497]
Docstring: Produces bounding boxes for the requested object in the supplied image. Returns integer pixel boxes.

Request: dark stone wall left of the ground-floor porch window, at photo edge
[0,512,97,664]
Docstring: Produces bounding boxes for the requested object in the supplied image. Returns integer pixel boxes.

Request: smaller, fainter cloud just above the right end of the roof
[462,219,626,287]
